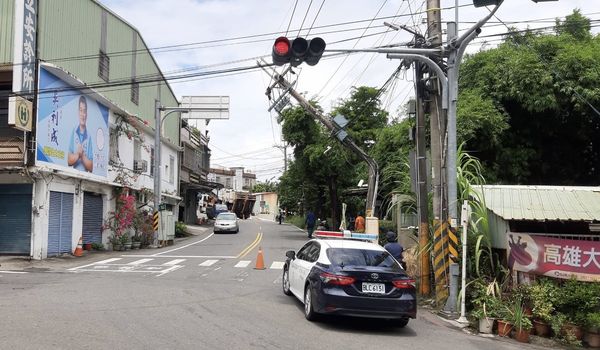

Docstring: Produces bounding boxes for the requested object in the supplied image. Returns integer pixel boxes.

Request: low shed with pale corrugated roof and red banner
[477,185,600,282]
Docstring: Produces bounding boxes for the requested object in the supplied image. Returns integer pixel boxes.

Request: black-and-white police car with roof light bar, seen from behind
[282,232,417,327]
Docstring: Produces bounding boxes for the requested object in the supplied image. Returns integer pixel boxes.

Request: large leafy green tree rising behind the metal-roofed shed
[458,11,600,185]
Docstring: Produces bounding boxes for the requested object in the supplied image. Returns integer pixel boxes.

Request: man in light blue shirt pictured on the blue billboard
[67,95,94,173]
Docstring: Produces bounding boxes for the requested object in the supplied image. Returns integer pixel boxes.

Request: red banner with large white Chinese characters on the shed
[508,232,600,282]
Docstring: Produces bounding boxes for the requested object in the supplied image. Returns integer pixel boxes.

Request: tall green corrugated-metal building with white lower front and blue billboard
[0,0,180,259]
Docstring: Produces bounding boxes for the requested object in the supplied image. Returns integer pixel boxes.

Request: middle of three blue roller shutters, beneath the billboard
[48,191,73,256]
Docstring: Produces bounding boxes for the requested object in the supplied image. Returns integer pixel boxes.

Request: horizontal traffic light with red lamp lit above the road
[272,36,326,67]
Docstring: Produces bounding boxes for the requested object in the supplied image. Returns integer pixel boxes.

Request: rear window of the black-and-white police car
[327,248,400,269]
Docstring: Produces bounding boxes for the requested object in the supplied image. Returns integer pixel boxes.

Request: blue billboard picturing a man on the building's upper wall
[36,67,109,177]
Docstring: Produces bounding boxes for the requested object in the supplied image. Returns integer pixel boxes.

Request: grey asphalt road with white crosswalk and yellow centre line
[0,218,540,350]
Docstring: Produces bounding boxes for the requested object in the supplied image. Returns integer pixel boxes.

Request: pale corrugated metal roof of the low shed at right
[477,185,600,221]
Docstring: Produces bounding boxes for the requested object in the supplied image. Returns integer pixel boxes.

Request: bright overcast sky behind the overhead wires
[101,0,600,181]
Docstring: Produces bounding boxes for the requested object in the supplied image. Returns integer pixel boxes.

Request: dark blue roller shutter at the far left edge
[0,184,33,256]
